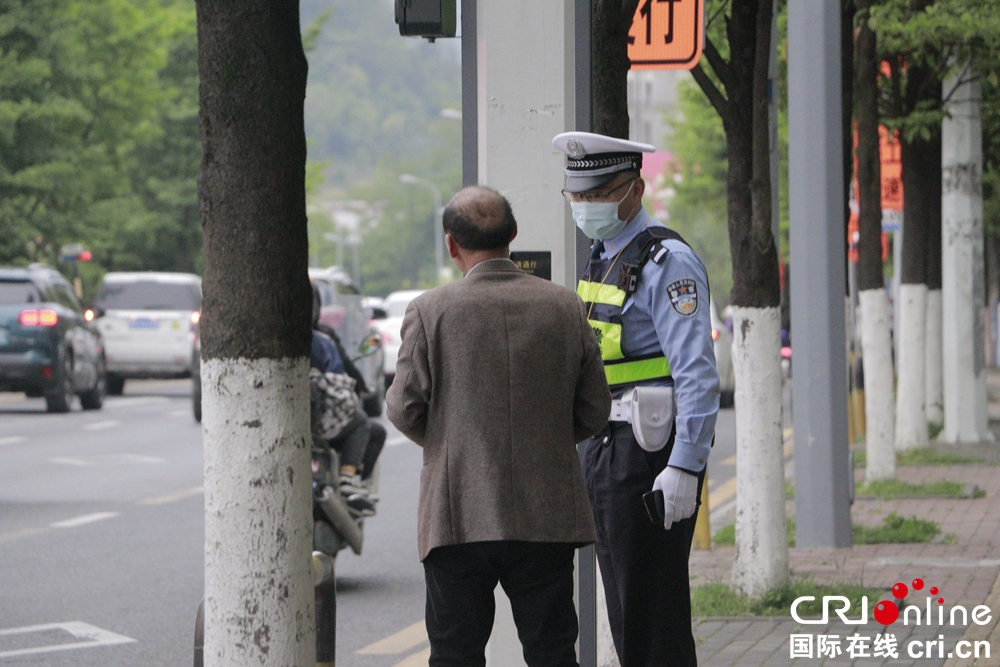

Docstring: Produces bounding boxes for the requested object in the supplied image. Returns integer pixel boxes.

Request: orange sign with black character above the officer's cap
[628,0,705,69]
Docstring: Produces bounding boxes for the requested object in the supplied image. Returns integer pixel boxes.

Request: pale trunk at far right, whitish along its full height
[939,64,993,443]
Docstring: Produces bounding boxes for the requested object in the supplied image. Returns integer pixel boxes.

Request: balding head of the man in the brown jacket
[442,185,517,250]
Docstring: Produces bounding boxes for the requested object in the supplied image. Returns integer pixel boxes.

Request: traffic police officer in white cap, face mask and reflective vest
[552,132,719,667]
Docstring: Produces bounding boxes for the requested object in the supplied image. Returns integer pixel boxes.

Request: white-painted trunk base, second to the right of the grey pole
[896,284,928,451]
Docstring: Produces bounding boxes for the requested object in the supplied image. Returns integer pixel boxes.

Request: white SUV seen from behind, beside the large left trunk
[94,271,201,395]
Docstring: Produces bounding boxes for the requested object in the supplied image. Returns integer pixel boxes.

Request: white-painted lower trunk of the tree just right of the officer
[732,306,789,598]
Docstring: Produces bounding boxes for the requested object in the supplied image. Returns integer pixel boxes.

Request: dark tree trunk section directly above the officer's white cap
[591,0,639,139]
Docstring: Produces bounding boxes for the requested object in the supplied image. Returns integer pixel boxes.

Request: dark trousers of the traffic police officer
[583,422,704,667]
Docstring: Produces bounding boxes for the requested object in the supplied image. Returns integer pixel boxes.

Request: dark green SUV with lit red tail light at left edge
[0,264,106,412]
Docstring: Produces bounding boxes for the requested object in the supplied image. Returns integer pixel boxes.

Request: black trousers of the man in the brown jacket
[424,540,578,667]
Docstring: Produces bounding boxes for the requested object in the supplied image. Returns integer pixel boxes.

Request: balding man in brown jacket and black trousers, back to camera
[386,187,611,667]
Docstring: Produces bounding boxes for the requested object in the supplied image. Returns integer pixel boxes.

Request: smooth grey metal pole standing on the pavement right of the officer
[788,0,853,548]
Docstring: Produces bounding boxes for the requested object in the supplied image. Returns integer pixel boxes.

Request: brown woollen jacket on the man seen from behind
[386,259,611,560]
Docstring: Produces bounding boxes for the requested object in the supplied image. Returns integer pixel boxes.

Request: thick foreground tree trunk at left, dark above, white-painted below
[197,0,316,667]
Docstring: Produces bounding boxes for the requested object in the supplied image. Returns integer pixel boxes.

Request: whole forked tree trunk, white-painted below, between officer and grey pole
[692,0,788,597]
